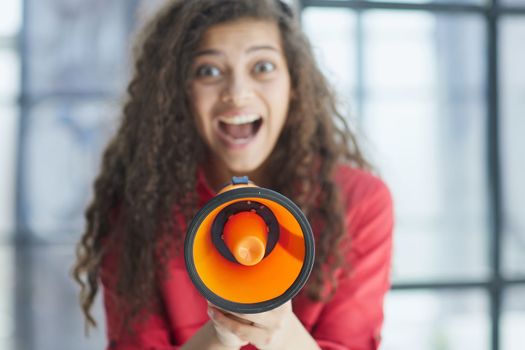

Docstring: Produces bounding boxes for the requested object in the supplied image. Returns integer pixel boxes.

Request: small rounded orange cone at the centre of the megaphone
[223,212,268,266]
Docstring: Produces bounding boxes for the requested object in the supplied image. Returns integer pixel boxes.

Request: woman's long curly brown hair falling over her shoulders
[73,0,368,326]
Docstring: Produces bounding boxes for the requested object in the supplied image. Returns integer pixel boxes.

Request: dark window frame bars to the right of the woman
[298,0,525,350]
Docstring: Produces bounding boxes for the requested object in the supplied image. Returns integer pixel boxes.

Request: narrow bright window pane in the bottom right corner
[501,286,525,350]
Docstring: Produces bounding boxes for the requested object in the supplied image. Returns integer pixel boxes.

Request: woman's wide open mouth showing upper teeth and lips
[218,114,262,145]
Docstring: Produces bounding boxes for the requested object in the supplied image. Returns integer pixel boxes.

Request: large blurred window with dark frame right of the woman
[299,0,525,350]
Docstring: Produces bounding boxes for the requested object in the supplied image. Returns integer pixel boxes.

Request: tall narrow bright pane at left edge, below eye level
[0,104,18,239]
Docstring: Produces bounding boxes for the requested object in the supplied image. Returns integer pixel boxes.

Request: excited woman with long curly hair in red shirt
[74,0,392,349]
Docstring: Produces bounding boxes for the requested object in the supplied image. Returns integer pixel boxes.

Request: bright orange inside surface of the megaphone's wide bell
[193,197,306,304]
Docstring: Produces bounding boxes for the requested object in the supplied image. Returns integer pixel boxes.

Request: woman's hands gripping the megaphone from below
[208,301,294,350]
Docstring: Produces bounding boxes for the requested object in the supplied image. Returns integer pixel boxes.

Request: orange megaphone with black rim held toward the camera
[184,177,315,314]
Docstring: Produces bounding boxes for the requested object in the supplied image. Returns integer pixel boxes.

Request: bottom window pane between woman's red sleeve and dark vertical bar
[381,291,490,350]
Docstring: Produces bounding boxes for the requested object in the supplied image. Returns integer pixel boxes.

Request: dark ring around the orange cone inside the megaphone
[211,201,279,263]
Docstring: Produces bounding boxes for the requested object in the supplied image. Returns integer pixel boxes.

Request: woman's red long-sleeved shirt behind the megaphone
[101,166,393,350]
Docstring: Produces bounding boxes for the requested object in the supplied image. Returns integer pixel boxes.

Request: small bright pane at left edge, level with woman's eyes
[0,48,20,104]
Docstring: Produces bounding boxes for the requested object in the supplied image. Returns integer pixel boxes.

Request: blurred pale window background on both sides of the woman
[0,0,525,350]
